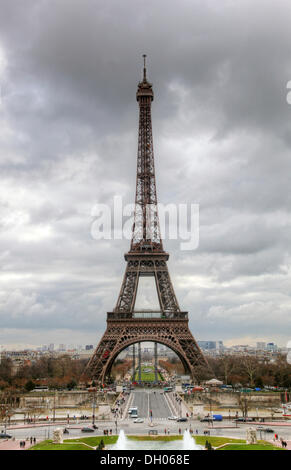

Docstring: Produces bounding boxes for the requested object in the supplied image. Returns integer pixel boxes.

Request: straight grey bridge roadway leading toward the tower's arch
[131,390,172,419]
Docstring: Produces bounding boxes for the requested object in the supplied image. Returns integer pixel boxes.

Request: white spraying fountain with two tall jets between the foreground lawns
[110,429,203,450]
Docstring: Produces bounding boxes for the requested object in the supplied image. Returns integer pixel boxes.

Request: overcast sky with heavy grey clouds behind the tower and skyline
[0,0,291,347]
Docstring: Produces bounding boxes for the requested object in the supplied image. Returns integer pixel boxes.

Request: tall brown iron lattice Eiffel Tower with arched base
[84,55,208,384]
